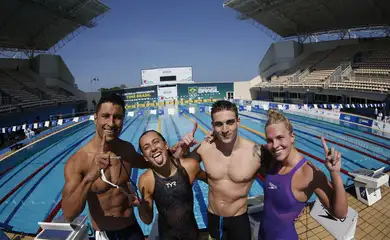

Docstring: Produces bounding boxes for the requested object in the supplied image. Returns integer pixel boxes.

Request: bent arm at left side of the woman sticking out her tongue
[138,172,154,224]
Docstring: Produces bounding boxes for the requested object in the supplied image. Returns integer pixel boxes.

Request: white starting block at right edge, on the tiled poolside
[351,167,389,206]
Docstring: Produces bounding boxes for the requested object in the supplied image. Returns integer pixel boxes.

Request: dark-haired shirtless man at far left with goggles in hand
[62,94,149,240]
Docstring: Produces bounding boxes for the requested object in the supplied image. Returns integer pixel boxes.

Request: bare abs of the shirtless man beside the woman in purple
[208,180,253,217]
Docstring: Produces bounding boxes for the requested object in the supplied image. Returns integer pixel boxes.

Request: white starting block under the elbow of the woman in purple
[310,198,358,240]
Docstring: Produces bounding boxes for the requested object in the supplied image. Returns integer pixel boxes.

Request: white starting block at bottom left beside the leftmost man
[35,215,89,240]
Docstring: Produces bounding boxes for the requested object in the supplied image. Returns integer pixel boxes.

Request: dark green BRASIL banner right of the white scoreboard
[177,83,234,100]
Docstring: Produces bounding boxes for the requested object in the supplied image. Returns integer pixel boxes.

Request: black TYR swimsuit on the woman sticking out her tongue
[153,160,199,240]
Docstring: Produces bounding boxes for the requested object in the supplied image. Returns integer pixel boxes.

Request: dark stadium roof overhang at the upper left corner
[0,0,109,51]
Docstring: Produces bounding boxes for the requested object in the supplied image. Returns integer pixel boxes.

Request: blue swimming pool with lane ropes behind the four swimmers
[0,105,390,235]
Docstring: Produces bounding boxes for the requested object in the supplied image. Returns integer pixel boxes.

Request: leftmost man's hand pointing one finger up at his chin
[85,135,110,182]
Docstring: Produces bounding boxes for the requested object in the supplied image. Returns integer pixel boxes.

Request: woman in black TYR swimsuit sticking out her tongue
[138,130,206,240]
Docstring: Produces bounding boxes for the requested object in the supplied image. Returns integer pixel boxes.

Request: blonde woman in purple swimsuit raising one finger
[259,110,348,240]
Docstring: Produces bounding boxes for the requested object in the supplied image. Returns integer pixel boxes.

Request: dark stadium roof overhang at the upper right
[224,0,390,38]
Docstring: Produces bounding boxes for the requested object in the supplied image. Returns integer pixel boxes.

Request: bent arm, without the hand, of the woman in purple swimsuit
[313,164,348,218]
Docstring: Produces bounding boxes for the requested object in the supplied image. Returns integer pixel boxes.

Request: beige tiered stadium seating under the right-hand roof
[259,39,390,93]
